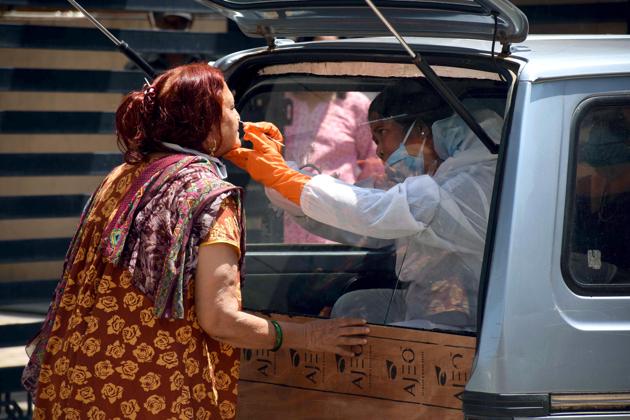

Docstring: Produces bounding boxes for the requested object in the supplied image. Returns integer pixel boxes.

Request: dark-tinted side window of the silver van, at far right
[564,98,630,294]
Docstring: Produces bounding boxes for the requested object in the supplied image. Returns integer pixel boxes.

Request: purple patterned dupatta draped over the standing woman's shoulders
[22,154,245,395]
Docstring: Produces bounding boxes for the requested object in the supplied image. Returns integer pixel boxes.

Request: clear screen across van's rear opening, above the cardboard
[238,63,508,331]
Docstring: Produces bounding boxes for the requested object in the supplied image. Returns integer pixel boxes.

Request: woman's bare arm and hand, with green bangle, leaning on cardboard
[195,243,369,356]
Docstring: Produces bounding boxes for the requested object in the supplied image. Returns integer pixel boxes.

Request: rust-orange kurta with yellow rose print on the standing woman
[34,159,241,420]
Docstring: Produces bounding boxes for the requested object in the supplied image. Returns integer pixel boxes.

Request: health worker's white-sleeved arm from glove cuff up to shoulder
[301,161,495,254]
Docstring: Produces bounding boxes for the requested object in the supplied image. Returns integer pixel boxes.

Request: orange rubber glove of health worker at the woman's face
[225,122,311,206]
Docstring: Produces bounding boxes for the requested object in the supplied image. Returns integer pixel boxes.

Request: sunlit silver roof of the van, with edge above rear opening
[221,35,630,82]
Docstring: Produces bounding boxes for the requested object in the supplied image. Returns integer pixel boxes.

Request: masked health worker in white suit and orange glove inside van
[227,80,503,328]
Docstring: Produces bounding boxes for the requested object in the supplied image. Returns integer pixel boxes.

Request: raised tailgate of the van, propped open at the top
[199,0,528,44]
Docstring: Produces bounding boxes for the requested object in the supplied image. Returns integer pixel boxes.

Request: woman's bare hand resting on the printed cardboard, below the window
[304,318,370,357]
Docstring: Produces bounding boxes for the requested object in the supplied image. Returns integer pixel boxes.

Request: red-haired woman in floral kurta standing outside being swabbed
[23,64,368,419]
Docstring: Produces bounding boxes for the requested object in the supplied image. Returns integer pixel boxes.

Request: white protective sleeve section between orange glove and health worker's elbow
[300,175,440,239]
